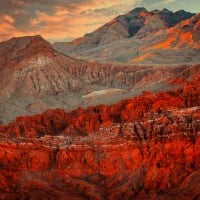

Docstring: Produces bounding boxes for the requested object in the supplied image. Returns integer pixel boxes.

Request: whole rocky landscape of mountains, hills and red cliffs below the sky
[0,8,200,200]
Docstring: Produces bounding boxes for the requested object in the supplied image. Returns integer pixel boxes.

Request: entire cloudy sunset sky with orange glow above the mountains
[0,0,200,43]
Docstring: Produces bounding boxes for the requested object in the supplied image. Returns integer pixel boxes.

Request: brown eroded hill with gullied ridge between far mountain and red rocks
[0,36,198,123]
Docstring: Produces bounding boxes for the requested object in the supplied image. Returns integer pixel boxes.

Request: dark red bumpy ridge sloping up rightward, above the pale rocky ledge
[0,71,200,137]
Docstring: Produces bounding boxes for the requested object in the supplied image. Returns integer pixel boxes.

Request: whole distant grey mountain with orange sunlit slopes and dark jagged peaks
[54,8,200,64]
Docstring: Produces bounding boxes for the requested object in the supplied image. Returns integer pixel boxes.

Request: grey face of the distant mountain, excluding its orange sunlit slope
[54,8,197,63]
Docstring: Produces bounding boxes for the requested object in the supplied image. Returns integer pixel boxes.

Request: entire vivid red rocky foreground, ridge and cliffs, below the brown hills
[0,69,200,200]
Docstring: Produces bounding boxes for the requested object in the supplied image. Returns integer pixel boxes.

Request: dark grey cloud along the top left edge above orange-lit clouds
[0,0,95,31]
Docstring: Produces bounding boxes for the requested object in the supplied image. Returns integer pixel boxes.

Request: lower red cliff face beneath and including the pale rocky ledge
[0,116,200,199]
